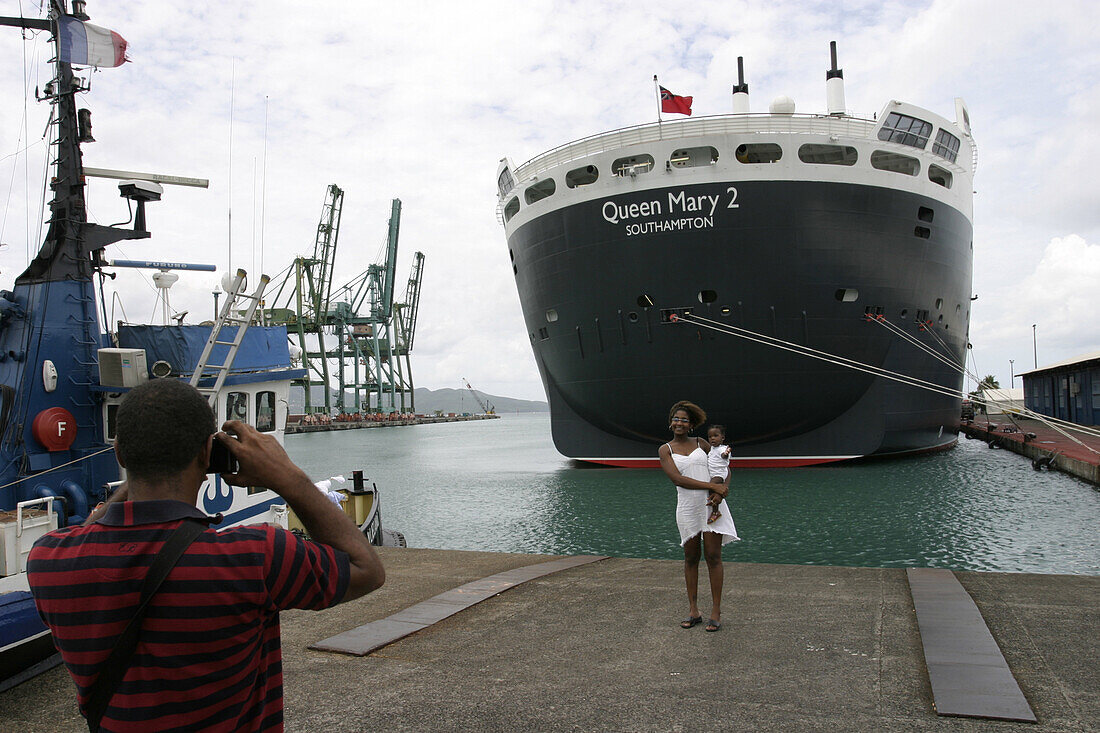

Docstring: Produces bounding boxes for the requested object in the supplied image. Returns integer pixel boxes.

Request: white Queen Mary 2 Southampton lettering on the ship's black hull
[601,186,739,237]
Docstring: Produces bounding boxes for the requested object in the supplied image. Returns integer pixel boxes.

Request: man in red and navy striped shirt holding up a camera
[28,380,385,731]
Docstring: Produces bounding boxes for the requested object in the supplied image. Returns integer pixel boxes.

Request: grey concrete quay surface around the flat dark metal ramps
[0,548,1100,733]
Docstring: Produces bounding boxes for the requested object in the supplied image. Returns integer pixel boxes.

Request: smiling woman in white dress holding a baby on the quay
[657,401,739,632]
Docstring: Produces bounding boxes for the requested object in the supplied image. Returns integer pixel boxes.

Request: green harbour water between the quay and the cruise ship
[286,414,1100,575]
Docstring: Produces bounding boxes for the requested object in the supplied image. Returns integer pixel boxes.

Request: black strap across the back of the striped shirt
[87,517,210,733]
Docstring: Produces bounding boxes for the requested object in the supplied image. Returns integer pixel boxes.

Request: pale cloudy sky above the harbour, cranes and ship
[0,0,1100,398]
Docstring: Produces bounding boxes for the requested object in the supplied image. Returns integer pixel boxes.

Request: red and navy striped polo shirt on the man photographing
[28,501,350,732]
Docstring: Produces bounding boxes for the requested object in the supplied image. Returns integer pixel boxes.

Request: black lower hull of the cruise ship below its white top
[508,180,972,466]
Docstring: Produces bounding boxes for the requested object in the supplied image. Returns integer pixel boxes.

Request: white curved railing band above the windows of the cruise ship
[515,113,878,180]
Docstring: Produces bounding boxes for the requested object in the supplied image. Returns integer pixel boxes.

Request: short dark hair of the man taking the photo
[114,379,216,479]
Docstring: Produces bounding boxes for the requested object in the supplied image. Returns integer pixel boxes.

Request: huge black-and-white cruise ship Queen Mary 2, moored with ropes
[497,44,977,467]
